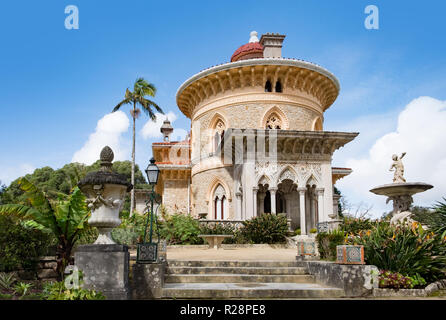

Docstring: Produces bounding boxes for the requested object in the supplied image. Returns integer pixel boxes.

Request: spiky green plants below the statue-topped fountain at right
[350,222,446,281]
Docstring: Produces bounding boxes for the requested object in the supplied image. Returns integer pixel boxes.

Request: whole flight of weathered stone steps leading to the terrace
[163,260,344,299]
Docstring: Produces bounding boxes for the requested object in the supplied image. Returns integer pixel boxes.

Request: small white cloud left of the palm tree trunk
[71,111,130,165]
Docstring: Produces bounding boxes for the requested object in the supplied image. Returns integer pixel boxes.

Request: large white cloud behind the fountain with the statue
[337,97,446,217]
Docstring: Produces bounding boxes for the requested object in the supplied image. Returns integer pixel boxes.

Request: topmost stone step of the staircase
[167,260,299,267]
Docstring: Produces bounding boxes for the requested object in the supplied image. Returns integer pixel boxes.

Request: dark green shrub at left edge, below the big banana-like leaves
[0,215,53,271]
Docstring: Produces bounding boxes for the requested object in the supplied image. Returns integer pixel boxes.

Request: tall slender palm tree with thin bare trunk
[112,78,164,215]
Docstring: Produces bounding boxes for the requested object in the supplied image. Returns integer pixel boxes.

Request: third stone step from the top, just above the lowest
[165,274,314,283]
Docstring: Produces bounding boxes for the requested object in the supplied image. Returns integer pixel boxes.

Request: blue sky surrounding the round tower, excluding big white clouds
[0,0,446,215]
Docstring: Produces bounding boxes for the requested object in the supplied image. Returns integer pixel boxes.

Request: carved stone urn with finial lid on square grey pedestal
[74,146,133,300]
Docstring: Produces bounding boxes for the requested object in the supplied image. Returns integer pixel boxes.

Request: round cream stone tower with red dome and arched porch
[172,31,357,234]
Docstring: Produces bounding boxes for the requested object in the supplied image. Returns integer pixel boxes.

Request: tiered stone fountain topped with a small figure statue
[370,152,433,224]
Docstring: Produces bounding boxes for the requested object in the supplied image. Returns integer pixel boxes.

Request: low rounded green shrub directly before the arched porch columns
[240,213,288,244]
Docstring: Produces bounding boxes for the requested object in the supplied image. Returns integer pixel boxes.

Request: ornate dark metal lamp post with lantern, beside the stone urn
[136,157,160,263]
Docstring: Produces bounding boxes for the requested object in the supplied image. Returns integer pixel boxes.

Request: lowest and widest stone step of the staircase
[163,283,344,299]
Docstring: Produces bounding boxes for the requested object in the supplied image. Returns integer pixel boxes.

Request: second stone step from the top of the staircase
[166,266,308,275]
